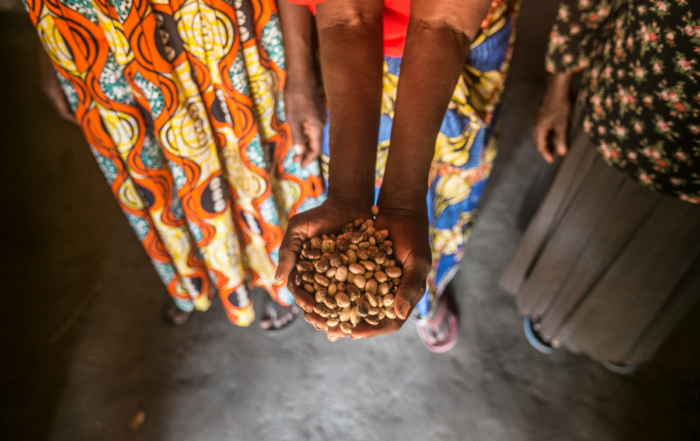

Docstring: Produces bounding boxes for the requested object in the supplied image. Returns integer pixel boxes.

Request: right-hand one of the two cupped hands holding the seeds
[318,205,432,341]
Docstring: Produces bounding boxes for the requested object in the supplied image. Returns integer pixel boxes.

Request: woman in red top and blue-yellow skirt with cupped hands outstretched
[280,0,518,352]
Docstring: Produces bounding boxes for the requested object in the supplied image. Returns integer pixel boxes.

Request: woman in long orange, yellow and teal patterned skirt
[31,0,325,328]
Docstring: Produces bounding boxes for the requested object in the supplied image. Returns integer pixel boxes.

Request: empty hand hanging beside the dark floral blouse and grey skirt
[532,74,571,163]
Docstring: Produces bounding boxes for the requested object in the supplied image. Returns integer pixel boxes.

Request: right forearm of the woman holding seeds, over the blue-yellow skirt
[378,1,488,210]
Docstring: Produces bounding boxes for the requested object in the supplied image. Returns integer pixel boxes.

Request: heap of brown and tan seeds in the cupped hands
[295,219,401,334]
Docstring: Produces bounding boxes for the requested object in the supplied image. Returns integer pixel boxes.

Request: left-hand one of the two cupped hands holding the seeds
[275,197,372,320]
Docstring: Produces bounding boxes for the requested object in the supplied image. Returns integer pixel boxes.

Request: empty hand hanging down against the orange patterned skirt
[284,81,325,167]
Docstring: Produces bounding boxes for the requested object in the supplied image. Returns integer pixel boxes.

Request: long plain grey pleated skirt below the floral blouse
[501,119,700,364]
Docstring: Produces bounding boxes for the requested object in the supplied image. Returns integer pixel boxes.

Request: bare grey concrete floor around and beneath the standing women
[0,0,700,441]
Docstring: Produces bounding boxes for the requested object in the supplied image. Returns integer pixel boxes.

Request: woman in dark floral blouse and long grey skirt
[502,0,700,372]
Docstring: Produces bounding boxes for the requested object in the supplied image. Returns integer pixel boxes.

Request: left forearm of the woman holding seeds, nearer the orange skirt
[316,1,383,207]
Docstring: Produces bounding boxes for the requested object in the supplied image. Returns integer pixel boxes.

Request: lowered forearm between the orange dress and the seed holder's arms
[278,0,316,87]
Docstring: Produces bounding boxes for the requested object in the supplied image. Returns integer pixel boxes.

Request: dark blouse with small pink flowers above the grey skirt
[546,0,700,204]
